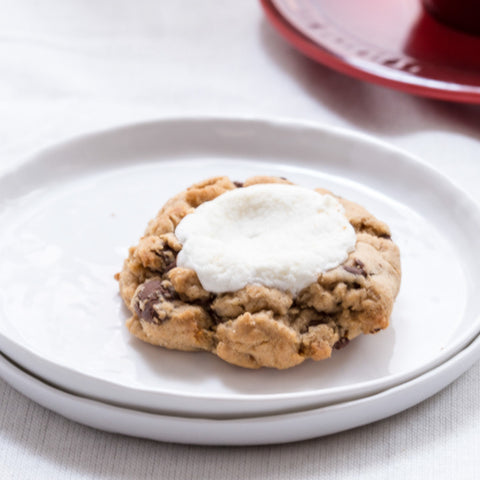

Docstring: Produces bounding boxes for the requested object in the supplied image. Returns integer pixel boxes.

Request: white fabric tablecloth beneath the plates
[0,0,480,480]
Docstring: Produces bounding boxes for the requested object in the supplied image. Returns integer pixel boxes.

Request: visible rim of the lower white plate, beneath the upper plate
[0,335,480,446]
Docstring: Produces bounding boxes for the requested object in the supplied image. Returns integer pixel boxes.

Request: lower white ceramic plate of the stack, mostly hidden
[0,337,480,445]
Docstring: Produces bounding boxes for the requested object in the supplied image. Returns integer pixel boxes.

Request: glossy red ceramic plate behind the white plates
[261,0,480,103]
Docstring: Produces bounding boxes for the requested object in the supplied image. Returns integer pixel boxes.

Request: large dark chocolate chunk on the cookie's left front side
[133,278,177,323]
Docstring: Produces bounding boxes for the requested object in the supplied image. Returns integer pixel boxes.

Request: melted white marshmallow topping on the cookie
[175,184,356,295]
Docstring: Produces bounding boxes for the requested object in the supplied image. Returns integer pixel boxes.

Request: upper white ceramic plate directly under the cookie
[0,119,480,418]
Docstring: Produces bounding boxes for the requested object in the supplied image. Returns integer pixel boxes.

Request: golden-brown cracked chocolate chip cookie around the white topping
[117,176,401,369]
